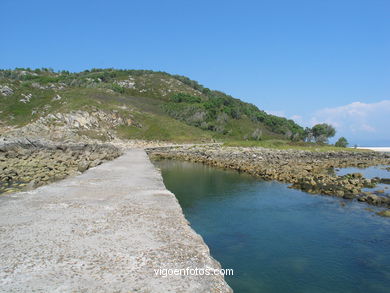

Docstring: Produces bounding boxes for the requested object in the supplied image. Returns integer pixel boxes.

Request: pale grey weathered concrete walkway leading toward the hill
[0,150,231,293]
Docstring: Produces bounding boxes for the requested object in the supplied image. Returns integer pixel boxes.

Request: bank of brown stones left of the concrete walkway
[0,141,122,194]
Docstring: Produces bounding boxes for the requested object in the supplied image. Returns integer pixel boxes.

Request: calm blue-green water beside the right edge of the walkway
[156,161,390,293]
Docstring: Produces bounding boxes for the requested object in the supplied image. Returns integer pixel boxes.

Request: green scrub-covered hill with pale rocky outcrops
[0,68,304,142]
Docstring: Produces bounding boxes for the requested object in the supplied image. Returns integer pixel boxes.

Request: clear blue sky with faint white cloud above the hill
[0,0,390,146]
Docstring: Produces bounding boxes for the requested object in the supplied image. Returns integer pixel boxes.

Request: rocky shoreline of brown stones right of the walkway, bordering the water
[148,146,390,208]
